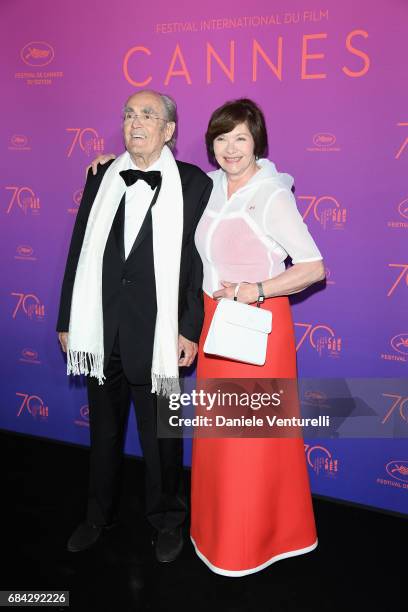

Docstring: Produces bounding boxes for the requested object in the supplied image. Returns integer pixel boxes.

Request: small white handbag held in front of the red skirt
[203,285,272,365]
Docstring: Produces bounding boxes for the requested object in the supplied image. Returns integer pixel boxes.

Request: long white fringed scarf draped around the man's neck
[67,146,183,396]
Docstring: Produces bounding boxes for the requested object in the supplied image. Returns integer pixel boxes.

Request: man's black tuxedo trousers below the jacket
[87,335,186,530]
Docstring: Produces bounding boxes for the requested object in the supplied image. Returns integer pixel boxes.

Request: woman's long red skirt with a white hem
[191,295,317,576]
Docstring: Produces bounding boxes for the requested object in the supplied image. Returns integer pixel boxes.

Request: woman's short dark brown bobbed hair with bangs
[205,98,268,160]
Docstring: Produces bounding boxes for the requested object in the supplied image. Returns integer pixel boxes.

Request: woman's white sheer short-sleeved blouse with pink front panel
[195,159,322,296]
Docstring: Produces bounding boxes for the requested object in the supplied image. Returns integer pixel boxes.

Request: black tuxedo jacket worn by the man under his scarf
[57,161,212,384]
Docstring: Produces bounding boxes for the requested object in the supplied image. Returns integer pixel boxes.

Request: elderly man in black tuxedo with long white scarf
[57,90,212,562]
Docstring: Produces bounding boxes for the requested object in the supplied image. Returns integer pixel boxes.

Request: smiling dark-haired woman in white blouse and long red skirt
[88,99,324,576]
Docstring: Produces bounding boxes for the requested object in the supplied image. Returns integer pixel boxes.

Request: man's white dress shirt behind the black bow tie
[125,157,161,258]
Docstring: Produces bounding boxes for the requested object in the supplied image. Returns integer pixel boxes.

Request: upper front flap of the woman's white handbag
[217,298,272,334]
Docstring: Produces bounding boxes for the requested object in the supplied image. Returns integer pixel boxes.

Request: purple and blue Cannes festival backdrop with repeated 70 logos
[0,0,408,513]
